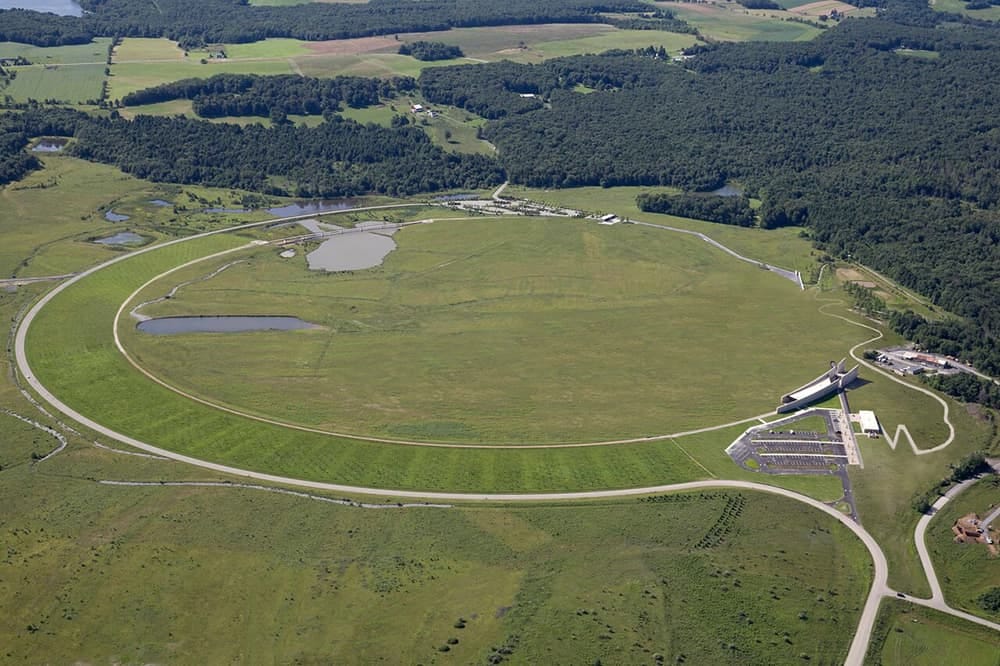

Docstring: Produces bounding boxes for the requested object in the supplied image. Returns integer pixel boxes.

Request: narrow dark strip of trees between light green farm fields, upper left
[121,74,416,118]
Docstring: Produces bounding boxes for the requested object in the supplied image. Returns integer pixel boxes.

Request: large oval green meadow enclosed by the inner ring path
[117,219,862,444]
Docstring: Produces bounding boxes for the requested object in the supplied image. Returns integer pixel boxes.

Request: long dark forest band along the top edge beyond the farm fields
[0,0,656,48]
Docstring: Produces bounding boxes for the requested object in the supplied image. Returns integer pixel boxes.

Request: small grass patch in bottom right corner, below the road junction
[865,599,1000,666]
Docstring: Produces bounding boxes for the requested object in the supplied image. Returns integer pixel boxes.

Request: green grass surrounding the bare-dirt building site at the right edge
[927,475,1000,621]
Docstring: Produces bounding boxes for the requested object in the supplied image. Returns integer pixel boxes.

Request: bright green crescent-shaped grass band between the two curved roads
[27,236,704,492]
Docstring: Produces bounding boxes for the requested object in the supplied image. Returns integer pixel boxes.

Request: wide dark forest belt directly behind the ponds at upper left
[0,109,503,197]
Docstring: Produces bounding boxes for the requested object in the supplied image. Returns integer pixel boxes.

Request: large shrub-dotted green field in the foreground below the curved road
[0,449,870,664]
